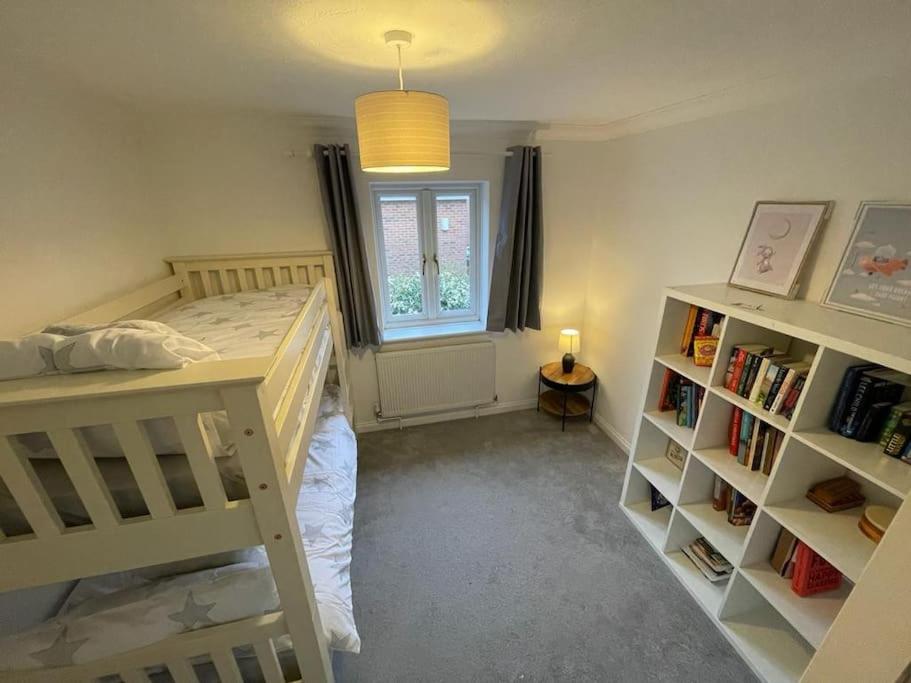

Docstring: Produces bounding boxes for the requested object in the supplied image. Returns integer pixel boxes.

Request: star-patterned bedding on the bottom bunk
[0,386,360,670]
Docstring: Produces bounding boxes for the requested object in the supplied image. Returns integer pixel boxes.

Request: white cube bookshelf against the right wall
[620,284,911,682]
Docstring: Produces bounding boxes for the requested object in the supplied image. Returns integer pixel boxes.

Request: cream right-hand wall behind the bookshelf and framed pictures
[583,74,911,446]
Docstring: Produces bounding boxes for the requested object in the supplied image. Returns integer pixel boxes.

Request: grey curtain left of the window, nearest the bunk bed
[313,145,380,349]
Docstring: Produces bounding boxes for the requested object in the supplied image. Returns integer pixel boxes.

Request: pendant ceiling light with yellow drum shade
[354,31,449,173]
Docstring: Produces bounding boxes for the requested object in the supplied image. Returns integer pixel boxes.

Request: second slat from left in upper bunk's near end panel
[47,429,121,529]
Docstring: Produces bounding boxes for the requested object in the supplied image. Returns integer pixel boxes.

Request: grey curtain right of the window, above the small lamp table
[487,147,544,332]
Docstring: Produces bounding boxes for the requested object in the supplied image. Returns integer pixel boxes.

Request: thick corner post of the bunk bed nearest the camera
[221,385,333,683]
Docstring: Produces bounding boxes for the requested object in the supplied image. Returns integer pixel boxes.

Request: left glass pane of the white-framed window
[380,195,424,316]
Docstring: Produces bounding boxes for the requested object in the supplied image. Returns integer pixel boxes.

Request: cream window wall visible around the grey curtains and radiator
[145,112,598,426]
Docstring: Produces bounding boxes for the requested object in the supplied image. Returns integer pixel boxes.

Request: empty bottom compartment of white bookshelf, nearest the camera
[721,571,814,681]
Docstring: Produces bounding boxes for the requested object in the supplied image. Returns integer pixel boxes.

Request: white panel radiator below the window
[376,342,497,417]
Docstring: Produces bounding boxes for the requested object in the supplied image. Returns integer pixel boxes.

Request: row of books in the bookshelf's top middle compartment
[724,344,810,419]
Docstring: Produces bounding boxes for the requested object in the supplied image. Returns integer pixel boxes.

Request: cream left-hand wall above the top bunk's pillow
[0,63,166,335]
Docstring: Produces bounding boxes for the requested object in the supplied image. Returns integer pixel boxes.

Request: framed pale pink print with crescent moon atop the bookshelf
[729,202,834,299]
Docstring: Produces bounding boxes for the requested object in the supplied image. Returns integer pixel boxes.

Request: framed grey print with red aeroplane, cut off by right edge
[823,202,911,326]
